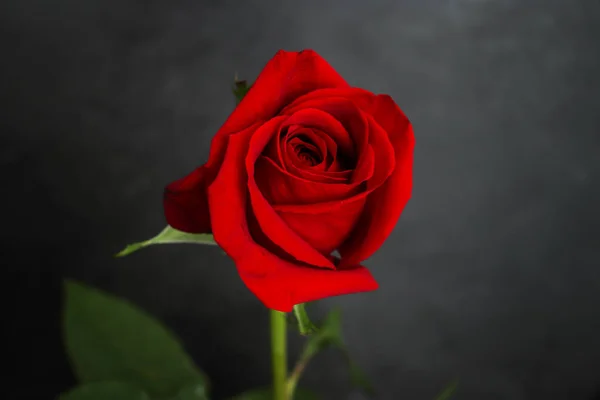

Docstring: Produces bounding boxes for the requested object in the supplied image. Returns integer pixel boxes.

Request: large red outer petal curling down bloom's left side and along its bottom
[208,126,377,312]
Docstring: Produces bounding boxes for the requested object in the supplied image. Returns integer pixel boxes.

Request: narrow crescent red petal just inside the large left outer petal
[245,116,335,269]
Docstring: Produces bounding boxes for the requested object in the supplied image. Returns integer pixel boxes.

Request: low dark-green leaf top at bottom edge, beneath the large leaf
[59,382,150,400]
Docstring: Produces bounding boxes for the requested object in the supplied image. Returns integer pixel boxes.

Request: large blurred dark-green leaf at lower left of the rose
[64,281,207,398]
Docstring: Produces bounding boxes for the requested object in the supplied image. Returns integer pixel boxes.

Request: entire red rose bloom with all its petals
[164,50,414,312]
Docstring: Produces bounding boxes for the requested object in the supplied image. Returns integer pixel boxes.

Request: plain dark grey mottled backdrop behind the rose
[0,0,600,400]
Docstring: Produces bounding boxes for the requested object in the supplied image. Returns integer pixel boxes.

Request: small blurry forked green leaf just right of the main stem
[302,310,375,395]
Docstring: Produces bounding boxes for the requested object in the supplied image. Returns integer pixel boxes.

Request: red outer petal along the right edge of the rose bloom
[339,95,415,268]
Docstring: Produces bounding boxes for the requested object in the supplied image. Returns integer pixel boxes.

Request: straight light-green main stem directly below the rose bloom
[271,310,289,400]
